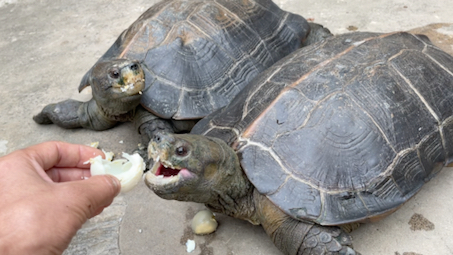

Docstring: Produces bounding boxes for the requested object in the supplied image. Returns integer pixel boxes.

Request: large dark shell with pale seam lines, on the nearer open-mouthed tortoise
[192,32,453,225]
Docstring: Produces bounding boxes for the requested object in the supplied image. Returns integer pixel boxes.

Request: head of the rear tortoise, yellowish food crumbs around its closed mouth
[79,59,145,113]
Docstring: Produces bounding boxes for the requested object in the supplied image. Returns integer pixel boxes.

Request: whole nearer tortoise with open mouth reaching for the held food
[145,32,453,254]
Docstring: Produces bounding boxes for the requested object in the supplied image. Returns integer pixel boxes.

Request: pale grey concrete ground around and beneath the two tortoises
[0,0,453,255]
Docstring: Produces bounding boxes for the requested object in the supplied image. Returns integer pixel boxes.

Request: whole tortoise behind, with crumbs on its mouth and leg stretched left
[33,0,330,149]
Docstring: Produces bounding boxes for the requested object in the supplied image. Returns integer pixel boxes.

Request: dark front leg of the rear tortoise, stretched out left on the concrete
[33,99,117,130]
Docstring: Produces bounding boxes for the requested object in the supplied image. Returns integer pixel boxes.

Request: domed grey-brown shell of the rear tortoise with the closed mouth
[84,0,310,119]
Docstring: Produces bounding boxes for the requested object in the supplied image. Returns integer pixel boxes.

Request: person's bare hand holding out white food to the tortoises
[0,142,121,254]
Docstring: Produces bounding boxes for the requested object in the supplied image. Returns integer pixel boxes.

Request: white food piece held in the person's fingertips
[88,151,146,192]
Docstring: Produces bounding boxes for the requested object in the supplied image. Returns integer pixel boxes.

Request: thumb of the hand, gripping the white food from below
[62,175,121,219]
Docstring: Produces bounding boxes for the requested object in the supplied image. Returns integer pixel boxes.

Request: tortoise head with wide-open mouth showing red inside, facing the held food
[145,133,248,204]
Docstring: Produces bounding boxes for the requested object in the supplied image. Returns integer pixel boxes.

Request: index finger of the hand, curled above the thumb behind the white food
[24,141,105,170]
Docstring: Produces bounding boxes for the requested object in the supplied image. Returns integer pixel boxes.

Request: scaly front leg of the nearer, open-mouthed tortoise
[254,192,360,255]
